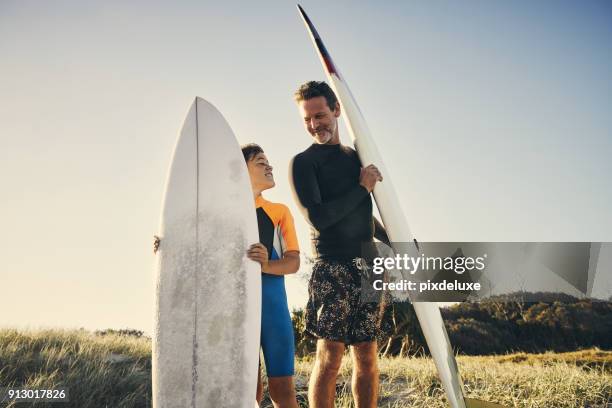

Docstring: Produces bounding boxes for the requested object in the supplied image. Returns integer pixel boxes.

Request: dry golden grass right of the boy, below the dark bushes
[270,349,612,408]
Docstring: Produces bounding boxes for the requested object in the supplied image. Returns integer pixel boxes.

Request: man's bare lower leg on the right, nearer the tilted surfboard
[351,341,378,408]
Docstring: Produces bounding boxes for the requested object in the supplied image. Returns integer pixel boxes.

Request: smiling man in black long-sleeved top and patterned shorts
[290,81,388,408]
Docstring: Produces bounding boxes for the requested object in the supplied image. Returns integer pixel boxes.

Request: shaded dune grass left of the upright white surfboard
[0,329,151,408]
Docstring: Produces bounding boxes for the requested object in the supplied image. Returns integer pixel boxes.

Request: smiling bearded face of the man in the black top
[299,96,340,144]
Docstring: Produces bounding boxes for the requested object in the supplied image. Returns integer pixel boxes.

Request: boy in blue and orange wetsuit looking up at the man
[242,144,300,408]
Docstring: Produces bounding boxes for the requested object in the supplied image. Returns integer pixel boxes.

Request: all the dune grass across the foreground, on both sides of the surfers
[0,329,612,408]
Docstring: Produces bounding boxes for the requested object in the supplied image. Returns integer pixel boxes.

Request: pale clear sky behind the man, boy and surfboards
[0,0,612,333]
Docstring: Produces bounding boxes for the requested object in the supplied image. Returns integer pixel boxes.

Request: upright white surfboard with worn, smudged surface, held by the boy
[152,98,261,408]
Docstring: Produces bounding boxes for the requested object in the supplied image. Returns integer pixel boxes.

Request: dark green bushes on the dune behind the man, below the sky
[293,293,612,356]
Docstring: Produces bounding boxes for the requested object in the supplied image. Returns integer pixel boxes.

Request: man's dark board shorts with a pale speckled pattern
[305,259,386,345]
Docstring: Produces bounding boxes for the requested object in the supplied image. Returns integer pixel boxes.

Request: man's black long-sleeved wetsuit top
[289,144,379,260]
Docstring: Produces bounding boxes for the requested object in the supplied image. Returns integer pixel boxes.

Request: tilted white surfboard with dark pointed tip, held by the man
[298,5,506,408]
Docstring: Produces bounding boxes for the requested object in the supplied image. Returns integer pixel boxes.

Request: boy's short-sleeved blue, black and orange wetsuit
[255,196,299,377]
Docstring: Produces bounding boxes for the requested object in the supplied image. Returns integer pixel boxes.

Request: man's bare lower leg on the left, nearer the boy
[308,339,344,408]
